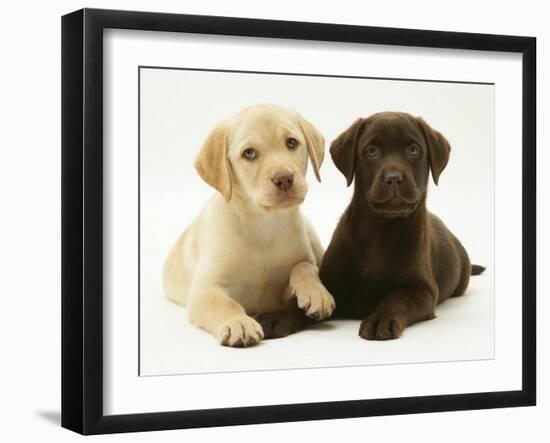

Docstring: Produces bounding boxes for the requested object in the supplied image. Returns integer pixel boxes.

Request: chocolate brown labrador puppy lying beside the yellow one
[320,112,484,340]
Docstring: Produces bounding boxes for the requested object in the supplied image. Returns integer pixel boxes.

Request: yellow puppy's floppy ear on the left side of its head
[195,122,232,201]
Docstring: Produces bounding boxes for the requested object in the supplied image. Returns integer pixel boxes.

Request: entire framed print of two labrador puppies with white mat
[62,9,536,434]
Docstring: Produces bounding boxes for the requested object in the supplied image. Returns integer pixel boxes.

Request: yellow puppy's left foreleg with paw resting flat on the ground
[188,285,264,347]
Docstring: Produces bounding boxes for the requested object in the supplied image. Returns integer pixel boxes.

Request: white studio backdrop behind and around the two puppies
[140,67,494,375]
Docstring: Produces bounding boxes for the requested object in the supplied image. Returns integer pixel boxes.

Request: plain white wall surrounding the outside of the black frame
[0,0,550,443]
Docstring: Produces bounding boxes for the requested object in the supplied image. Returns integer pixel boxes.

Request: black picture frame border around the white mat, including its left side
[61,9,536,434]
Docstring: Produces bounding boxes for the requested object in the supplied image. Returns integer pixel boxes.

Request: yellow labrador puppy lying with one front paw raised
[163,105,335,346]
